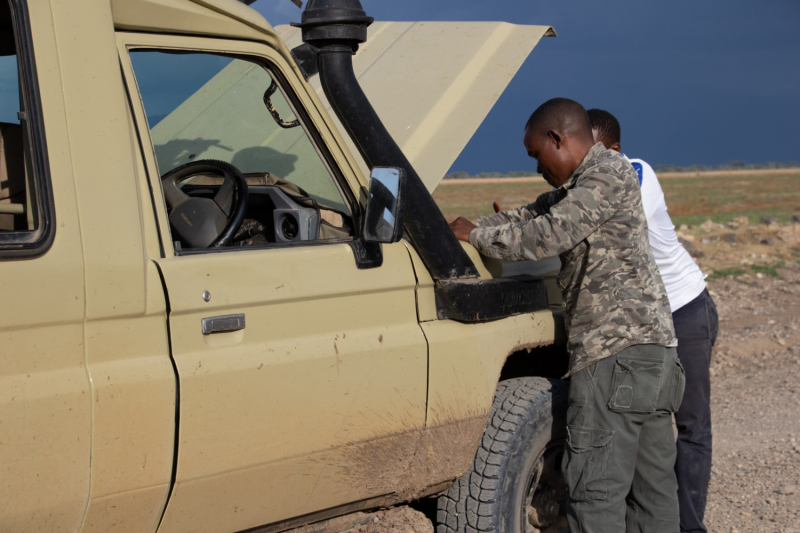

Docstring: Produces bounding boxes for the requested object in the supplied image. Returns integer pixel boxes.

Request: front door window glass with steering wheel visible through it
[130,50,353,249]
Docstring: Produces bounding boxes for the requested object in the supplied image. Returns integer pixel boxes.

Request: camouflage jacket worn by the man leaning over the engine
[469,143,677,375]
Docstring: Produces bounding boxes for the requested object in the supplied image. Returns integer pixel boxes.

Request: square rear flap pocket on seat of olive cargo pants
[608,357,664,413]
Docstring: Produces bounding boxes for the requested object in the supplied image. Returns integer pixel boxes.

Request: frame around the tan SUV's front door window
[117,36,363,257]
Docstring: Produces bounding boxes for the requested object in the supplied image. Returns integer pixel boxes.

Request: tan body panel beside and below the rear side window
[0,2,92,531]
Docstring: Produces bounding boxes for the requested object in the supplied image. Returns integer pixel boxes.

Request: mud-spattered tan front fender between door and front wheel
[398,243,566,485]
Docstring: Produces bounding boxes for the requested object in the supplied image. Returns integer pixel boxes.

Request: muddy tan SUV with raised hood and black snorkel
[0,0,565,533]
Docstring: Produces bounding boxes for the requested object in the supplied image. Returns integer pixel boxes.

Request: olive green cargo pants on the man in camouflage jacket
[562,344,685,533]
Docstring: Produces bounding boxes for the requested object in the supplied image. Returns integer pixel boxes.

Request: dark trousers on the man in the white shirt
[672,290,719,533]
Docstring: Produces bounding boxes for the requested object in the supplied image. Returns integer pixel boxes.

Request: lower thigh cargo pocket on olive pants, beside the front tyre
[563,426,614,502]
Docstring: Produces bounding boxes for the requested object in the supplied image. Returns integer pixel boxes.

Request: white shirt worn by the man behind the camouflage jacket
[626,156,706,313]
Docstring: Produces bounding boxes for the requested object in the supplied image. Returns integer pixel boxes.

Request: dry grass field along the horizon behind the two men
[433,171,800,225]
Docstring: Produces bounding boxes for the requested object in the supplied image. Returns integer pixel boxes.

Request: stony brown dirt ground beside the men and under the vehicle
[364,218,800,533]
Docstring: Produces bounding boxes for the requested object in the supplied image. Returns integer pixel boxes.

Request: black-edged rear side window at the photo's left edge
[0,0,53,256]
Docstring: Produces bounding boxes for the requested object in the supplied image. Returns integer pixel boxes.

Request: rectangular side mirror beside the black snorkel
[364,167,406,243]
